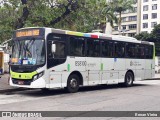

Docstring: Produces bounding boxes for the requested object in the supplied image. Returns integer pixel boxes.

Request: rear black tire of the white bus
[124,72,134,87]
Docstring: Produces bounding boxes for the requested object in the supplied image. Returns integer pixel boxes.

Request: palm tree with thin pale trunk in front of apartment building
[110,0,134,31]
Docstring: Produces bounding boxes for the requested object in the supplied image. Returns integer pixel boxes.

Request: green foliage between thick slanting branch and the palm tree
[55,0,106,32]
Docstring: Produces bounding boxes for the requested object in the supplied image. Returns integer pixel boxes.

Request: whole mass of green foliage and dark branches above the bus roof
[0,0,112,42]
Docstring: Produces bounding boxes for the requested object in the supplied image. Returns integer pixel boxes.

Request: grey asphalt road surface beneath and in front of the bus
[0,80,160,120]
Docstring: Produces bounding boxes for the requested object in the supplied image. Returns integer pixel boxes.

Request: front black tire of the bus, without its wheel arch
[66,74,79,93]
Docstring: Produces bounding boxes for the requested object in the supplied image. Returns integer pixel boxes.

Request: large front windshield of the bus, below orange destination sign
[11,39,45,65]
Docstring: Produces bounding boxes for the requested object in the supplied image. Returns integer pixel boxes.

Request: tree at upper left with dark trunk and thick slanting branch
[0,0,83,41]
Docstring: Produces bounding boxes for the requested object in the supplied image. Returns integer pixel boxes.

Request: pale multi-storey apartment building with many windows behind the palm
[112,0,160,36]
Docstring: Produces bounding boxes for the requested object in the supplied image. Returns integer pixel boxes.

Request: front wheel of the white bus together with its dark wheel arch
[66,71,83,93]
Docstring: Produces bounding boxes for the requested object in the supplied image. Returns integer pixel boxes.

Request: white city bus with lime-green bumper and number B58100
[10,28,155,92]
